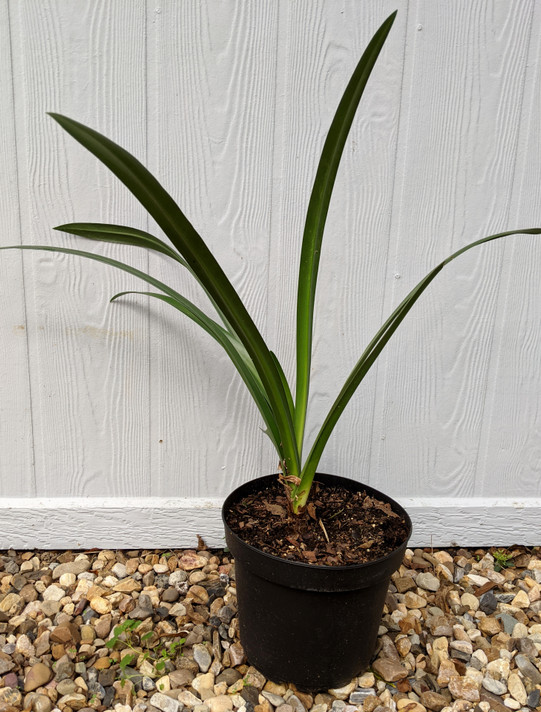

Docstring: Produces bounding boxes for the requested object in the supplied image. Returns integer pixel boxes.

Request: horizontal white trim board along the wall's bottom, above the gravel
[0,497,541,550]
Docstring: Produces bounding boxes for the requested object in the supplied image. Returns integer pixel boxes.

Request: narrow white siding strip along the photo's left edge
[0,3,35,497]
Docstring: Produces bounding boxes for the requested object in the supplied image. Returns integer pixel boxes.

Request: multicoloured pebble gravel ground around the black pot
[0,542,541,712]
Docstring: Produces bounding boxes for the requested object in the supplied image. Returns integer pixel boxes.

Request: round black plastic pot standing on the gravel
[222,473,411,691]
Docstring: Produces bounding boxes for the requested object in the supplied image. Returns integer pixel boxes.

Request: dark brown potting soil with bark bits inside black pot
[227,478,408,566]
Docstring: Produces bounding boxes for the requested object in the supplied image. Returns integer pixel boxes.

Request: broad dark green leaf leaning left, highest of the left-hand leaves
[50,114,300,475]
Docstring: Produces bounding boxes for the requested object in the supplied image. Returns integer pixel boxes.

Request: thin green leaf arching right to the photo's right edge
[295,228,541,508]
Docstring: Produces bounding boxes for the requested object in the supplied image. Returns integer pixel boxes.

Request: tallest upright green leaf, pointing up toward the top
[295,12,396,453]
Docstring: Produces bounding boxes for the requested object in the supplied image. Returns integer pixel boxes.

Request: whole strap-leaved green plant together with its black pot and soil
[2,13,541,689]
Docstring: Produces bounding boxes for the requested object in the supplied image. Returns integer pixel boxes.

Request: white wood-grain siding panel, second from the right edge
[376,1,532,496]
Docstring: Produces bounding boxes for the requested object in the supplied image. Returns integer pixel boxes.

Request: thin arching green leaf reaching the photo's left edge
[0,245,283,459]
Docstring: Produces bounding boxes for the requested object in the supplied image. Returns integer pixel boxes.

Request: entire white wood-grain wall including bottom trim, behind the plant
[0,0,541,548]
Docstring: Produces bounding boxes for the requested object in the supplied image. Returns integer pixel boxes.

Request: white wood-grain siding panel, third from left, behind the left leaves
[148,1,278,496]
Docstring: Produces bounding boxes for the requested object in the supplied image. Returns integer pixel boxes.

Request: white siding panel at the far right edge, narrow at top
[476,3,541,497]
